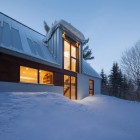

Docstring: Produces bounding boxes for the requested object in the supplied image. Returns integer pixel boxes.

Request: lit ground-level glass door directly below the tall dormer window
[64,75,77,100]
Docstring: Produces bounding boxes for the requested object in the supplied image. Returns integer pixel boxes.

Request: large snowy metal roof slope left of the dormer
[0,13,57,66]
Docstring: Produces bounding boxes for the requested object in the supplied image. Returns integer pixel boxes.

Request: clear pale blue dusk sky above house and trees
[0,0,140,74]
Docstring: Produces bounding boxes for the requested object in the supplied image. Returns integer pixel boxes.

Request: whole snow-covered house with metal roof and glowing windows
[0,13,101,99]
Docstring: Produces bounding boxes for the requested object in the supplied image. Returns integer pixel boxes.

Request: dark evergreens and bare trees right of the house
[100,42,140,101]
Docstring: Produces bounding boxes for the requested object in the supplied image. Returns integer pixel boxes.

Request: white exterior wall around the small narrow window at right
[77,74,101,100]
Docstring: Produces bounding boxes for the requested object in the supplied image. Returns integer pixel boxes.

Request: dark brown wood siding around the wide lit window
[0,53,64,86]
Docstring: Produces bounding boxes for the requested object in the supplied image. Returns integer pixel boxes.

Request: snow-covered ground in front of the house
[0,93,140,140]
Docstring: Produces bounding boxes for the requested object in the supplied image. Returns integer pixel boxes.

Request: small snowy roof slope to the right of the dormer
[82,60,101,78]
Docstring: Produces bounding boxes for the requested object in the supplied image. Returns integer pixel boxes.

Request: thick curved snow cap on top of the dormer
[46,19,85,42]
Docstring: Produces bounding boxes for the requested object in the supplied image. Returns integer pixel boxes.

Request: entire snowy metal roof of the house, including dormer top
[0,13,100,78]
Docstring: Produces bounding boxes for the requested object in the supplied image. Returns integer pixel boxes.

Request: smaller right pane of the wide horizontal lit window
[39,70,53,84]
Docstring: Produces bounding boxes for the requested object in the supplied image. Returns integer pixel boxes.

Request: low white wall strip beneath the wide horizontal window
[0,82,63,95]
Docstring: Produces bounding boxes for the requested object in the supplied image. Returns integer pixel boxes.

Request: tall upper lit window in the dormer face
[64,40,79,72]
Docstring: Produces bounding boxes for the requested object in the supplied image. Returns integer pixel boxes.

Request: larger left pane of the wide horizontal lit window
[20,66,38,83]
